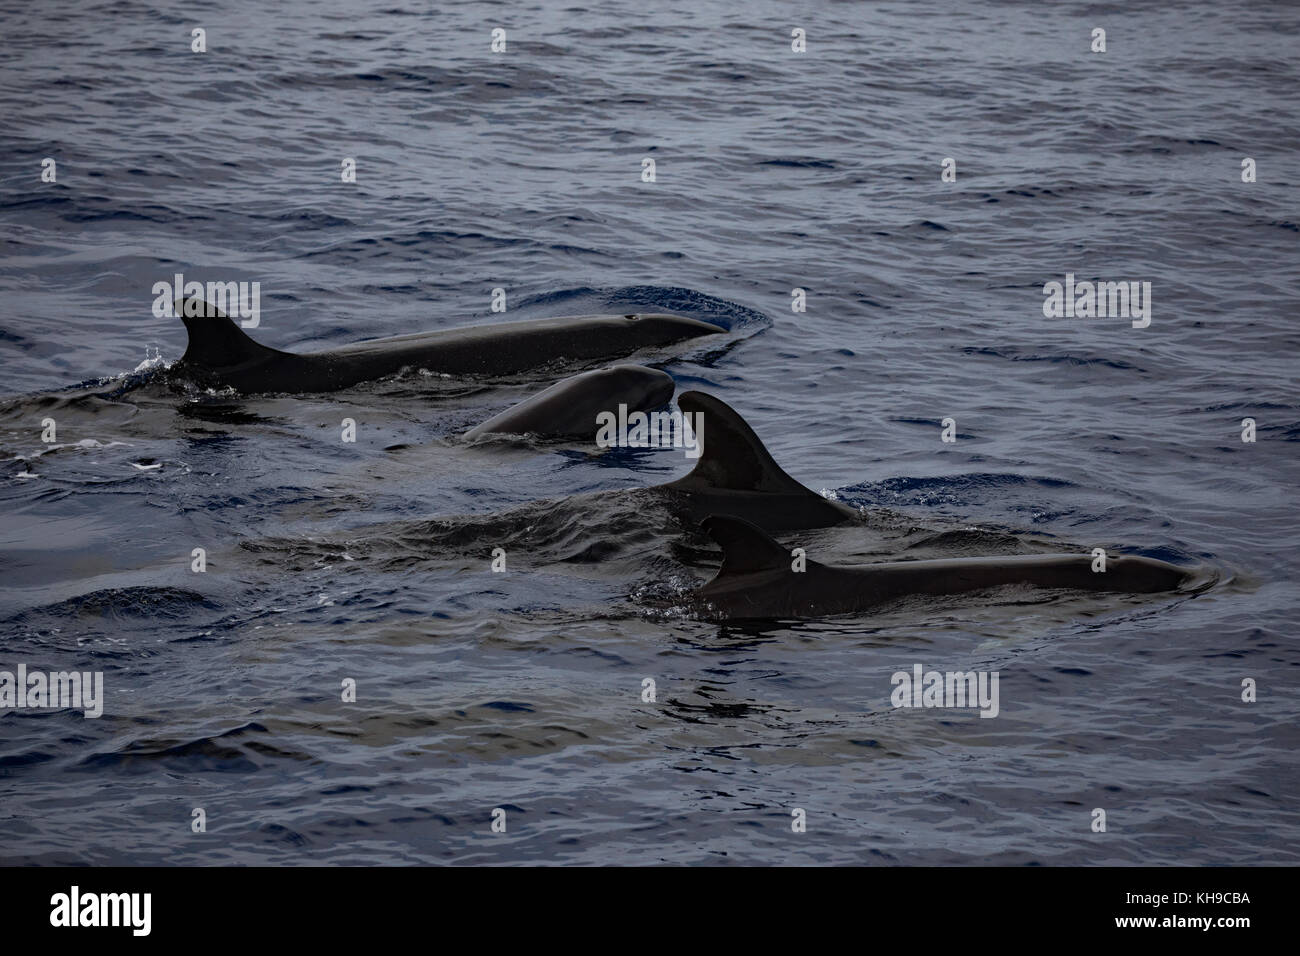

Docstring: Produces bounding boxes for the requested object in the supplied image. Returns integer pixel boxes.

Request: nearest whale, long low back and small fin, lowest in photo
[692,515,1209,619]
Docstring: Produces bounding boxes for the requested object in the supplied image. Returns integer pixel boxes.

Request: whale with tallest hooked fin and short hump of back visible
[649,390,858,533]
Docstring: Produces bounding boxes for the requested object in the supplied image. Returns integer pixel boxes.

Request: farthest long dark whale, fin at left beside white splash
[167,297,725,393]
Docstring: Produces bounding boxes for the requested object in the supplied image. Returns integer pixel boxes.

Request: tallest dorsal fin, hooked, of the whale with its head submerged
[664,392,820,497]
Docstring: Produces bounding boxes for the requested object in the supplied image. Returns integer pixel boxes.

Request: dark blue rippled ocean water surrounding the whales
[0,0,1300,865]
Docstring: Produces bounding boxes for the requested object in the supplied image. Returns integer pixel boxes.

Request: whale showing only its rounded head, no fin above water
[462,365,677,441]
